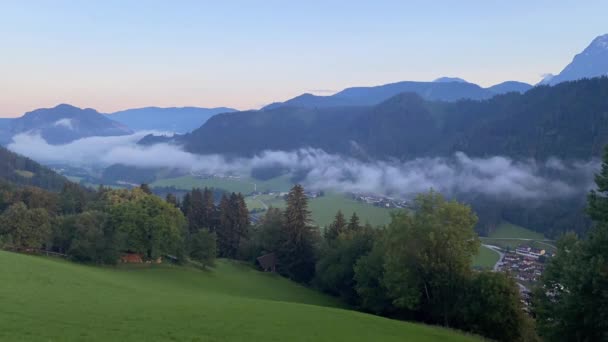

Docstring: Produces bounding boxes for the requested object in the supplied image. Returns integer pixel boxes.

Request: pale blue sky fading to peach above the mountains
[0,0,608,117]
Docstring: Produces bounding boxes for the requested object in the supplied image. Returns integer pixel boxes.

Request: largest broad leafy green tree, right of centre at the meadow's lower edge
[384,191,480,326]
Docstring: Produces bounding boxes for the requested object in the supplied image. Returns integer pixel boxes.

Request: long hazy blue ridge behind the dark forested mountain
[263,77,531,110]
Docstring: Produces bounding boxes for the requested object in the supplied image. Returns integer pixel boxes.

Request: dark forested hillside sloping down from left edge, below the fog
[0,147,68,191]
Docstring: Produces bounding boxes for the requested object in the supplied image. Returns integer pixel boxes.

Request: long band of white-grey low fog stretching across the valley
[8,132,600,200]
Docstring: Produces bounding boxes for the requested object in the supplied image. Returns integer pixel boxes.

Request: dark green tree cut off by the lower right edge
[533,147,608,341]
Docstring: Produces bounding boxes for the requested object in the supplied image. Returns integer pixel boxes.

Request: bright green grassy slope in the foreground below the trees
[0,251,477,341]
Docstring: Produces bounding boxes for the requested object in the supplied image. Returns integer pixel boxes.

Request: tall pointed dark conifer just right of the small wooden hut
[277,185,319,283]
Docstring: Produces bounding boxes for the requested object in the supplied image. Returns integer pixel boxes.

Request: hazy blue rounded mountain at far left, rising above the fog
[0,104,132,145]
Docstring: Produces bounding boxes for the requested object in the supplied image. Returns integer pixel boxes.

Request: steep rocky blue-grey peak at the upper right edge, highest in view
[540,34,608,85]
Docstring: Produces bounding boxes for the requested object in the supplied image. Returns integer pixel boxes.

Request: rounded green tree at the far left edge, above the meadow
[0,202,51,249]
